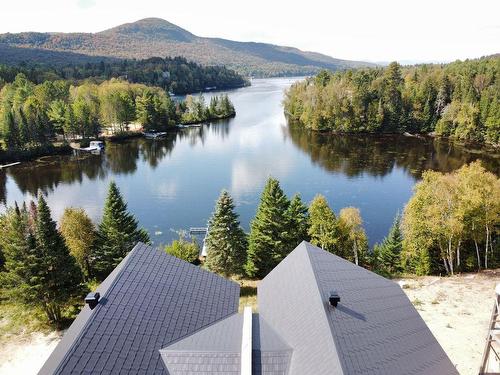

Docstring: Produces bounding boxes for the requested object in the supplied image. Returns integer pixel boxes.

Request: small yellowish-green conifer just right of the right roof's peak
[309,195,341,255]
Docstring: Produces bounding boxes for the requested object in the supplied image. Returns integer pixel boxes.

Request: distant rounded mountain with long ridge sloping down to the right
[0,18,374,76]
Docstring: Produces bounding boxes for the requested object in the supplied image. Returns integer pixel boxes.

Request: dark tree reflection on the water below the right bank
[284,126,500,179]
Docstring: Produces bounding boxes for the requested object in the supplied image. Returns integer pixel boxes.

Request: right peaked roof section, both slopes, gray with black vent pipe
[258,242,458,374]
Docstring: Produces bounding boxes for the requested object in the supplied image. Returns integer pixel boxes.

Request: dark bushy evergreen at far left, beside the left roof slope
[0,196,83,323]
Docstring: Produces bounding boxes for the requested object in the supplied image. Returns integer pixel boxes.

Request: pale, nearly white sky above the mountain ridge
[0,0,500,61]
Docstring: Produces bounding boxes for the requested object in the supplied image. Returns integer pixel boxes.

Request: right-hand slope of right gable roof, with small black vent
[303,243,458,375]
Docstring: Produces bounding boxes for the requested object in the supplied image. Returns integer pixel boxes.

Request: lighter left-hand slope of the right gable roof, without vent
[257,243,342,375]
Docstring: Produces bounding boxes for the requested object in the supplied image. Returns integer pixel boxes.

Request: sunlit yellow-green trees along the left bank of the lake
[0,73,235,156]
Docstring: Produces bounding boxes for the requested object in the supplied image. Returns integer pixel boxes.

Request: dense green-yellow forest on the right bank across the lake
[284,56,500,145]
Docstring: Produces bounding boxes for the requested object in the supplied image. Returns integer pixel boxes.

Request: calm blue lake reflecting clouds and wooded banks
[0,78,500,244]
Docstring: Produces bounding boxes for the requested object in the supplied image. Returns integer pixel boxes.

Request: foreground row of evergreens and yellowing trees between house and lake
[0,162,500,327]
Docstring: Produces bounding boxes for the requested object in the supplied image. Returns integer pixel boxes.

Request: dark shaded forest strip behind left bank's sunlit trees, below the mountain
[0,57,249,94]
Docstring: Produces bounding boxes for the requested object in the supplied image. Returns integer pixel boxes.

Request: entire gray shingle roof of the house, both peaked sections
[41,242,457,375]
